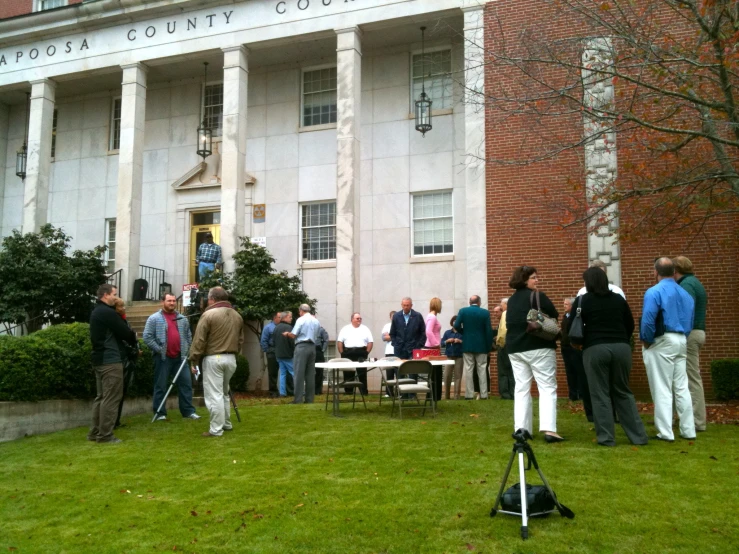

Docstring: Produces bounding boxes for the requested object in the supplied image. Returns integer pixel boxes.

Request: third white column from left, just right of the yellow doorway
[221,46,249,271]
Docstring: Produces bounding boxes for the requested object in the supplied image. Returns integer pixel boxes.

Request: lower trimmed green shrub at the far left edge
[0,335,68,401]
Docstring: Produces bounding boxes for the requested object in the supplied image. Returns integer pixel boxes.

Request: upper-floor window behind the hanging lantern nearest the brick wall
[411,48,454,110]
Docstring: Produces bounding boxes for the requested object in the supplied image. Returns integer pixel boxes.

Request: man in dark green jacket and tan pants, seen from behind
[454,295,493,400]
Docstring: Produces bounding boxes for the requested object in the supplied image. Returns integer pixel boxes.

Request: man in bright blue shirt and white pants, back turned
[640,254,695,442]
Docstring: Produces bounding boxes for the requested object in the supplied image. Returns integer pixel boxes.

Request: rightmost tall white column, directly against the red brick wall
[462,2,488,305]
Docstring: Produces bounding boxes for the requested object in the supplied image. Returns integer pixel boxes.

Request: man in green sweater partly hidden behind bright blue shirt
[672,256,707,431]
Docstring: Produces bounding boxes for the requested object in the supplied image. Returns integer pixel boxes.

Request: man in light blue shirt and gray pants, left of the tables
[283,304,321,404]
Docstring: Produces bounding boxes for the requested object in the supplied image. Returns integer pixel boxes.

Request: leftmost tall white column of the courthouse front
[23,79,56,233]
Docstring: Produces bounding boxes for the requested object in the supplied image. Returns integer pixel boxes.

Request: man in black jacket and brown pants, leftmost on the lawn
[87,284,136,443]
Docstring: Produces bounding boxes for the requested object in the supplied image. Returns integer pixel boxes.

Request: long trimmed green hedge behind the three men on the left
[0,323,249,402]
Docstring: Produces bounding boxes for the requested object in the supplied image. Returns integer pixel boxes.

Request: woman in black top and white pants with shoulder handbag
[506,265,565,442]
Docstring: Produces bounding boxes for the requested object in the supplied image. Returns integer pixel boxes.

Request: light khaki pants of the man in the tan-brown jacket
[203,354,236,437]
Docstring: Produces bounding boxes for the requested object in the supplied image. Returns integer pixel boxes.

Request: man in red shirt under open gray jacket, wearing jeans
[143,294,200,421]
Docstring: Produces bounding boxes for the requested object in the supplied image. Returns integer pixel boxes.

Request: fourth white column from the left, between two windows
[336,27,362,320]
